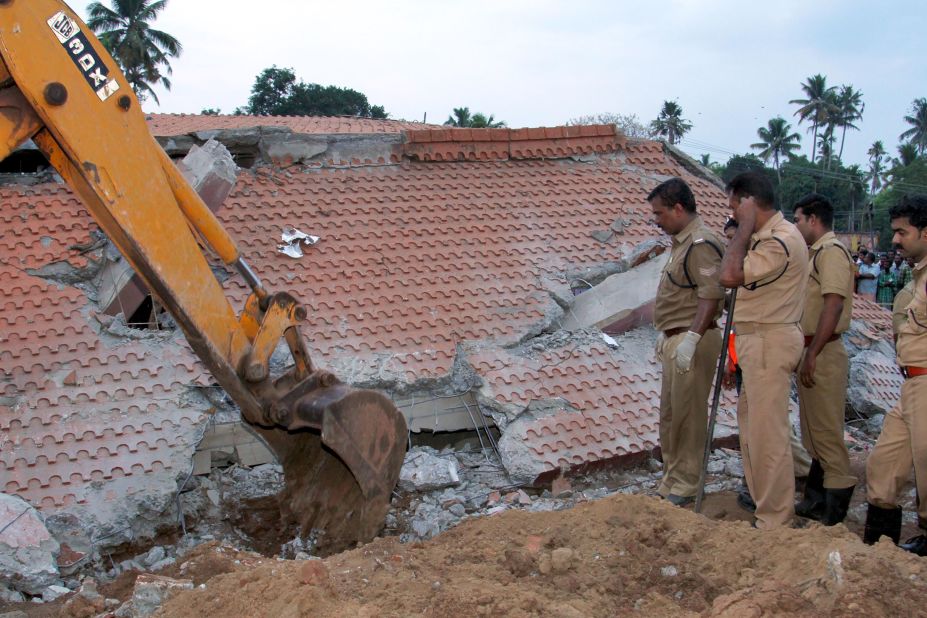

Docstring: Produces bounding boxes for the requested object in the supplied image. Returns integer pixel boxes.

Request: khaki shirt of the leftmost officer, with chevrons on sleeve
[653,216,724,331]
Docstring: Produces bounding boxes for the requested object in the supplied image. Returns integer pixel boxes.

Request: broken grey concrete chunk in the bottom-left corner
[0,494,60,596]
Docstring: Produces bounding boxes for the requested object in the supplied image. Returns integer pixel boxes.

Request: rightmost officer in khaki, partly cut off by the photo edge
[863,195,927,556]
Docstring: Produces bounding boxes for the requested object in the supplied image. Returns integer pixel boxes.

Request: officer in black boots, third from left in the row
[795,193,856,526]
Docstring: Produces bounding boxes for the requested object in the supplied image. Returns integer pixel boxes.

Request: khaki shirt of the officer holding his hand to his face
[734,212,810,324]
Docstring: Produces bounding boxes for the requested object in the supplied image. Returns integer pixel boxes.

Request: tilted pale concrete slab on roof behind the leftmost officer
[563,254,668,334]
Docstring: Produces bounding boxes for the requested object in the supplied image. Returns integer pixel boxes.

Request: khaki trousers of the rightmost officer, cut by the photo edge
[866,376,927,528]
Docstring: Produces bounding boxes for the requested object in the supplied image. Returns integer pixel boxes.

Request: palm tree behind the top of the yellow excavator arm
[87,0,183,103]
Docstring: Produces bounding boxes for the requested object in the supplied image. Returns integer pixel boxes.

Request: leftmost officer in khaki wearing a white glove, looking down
[647,178,724,506]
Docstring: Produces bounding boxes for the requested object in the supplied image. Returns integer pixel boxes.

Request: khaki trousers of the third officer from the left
[798,339,856,489]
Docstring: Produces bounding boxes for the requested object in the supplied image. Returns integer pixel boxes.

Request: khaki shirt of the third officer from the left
[801,232,855,336]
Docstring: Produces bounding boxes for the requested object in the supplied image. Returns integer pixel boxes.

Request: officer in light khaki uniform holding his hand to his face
[720,172,808,529]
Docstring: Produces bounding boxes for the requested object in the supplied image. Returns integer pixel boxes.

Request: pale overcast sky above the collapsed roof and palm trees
[110,0,927,163]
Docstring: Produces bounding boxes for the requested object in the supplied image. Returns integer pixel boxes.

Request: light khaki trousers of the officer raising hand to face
[735,324,805,529]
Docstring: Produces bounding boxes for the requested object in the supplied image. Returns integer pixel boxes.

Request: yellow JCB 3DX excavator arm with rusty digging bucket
[0,0,407,546]
